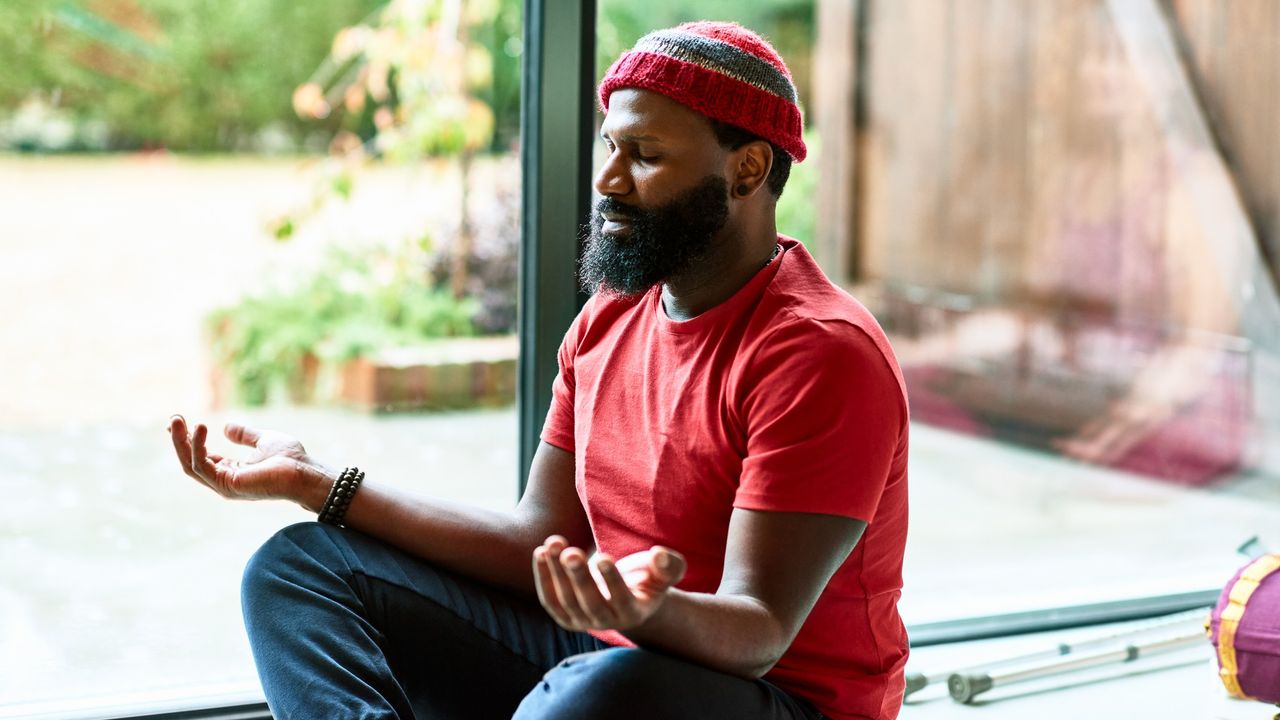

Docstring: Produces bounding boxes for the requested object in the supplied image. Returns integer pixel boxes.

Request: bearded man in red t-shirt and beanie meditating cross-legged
[172,23,908,719]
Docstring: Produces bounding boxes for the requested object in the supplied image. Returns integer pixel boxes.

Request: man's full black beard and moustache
[579,176,728,297]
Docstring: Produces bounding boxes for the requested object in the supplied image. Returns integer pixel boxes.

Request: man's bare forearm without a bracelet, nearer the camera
[625,589,794,678]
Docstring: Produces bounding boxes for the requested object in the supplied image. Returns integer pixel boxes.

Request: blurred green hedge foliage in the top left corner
[0,0,383,151]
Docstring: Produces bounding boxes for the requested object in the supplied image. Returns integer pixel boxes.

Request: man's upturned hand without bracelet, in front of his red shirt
[534,536,685,632]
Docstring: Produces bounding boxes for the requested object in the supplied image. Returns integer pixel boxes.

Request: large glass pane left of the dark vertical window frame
[0,0,521,714]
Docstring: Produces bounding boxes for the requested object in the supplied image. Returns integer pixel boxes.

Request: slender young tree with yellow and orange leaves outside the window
[281,0,513,299]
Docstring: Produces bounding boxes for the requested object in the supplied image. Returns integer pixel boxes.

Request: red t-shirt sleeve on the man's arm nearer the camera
[733,319,906,523]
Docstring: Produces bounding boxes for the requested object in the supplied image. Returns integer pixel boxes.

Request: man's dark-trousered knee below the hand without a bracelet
[515,647,678,720]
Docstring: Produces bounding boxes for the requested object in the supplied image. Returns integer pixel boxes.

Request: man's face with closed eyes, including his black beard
[581,88,730,295]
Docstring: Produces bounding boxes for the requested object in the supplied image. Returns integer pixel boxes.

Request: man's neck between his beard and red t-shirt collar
[662,215,778,322]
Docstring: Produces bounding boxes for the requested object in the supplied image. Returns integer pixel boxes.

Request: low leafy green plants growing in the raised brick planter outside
[207,241,477,405]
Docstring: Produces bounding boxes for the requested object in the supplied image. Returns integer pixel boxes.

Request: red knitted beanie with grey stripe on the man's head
[599,20,808,163]
